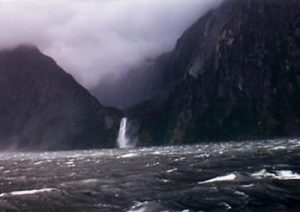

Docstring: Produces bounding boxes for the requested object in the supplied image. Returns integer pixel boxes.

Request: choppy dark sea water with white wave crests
[0,139,300,212]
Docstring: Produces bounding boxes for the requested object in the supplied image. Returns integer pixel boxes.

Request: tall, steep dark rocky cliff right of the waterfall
[129,0,300,145]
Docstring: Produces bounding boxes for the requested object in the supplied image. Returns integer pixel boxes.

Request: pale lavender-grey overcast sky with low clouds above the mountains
[0,0,220,88]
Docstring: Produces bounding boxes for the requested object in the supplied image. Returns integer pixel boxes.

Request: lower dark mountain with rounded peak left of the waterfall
[0,46,120,150]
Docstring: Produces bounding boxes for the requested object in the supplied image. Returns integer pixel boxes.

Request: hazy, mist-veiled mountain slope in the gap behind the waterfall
[91,53,176,109]
